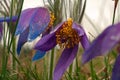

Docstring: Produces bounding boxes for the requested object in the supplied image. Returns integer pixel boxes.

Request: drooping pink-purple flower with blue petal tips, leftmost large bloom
[15,7,54,55]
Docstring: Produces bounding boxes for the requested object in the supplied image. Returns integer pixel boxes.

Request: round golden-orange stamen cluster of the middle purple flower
[56,18,80,48]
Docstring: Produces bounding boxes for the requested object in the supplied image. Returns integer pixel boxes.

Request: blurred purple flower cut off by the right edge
[82,23,120,80]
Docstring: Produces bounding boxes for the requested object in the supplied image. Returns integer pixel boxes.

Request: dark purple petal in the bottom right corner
[112,55,120,80]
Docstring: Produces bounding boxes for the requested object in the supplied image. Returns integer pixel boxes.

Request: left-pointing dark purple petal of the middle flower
[34,33,56,51]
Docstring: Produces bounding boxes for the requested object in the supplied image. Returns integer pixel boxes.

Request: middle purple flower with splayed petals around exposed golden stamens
[35,18,89,80]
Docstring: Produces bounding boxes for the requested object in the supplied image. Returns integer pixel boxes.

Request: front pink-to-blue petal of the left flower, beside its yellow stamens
[28,8,50,41]
